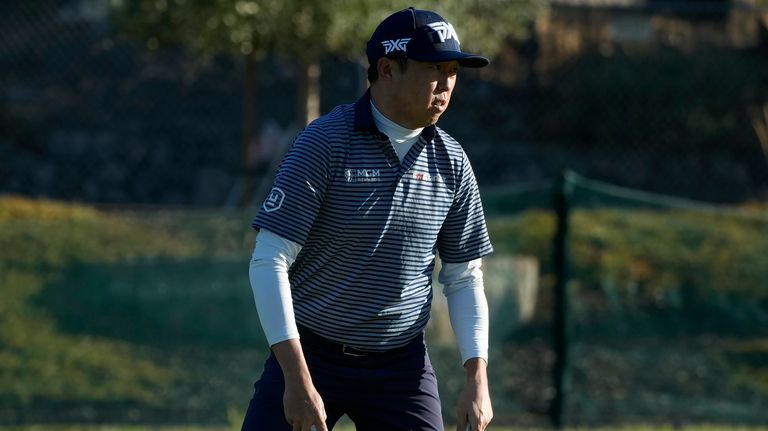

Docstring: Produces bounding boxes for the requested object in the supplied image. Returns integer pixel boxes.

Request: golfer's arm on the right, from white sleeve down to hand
[439,259,493,431]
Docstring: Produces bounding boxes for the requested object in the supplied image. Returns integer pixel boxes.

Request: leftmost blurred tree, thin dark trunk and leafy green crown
[112,0,289,205]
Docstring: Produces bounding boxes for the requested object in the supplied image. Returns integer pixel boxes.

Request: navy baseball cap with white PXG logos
[366,7,490,67]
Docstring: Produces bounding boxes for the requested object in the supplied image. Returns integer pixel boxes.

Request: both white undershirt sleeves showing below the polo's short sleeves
[249,229,488,363]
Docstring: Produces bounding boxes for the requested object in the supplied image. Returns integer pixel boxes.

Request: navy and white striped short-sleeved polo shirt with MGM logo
[252,93,492,351]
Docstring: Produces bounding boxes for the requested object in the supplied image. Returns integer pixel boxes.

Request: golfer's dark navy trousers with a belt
[242,328,443,431]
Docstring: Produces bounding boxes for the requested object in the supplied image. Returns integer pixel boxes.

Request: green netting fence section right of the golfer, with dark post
[487,172,768,426]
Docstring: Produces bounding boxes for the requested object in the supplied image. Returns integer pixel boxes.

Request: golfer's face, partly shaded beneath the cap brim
[389,59,459,129]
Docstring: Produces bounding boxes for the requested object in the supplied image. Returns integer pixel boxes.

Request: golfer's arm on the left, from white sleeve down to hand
[248,229,327,431]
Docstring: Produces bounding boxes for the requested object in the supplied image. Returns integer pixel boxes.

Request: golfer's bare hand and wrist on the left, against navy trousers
[272,338,328,431]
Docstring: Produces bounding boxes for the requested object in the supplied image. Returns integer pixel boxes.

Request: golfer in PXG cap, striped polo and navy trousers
[243,8,493,431]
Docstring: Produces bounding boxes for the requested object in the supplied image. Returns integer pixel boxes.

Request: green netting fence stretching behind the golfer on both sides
[0,173,768,428]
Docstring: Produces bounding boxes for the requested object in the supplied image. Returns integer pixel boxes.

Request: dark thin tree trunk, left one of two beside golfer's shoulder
[240,55,259,207]
